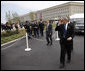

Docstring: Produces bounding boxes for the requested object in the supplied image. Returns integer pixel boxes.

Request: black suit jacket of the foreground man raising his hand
[55,22,74,44]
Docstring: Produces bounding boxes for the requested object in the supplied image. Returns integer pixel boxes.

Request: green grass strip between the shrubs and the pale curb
[1,30,26,44]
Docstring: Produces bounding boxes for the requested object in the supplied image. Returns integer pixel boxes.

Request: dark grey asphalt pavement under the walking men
[1,32,84,70]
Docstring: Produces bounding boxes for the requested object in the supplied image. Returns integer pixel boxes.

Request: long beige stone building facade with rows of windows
[20,2,84,21]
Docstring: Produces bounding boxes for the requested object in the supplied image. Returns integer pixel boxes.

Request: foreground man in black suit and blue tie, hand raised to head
[55,18,74,68]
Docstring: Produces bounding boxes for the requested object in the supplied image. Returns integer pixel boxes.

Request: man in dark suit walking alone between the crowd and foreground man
[46,21,52,45]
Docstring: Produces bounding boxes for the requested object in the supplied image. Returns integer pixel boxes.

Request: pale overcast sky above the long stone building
[1,1,84,23]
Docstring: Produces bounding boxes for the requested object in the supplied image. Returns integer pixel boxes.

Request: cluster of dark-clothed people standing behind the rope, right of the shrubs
[24,20,44,38]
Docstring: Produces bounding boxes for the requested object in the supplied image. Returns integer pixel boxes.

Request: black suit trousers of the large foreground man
[60,39,72,64]
